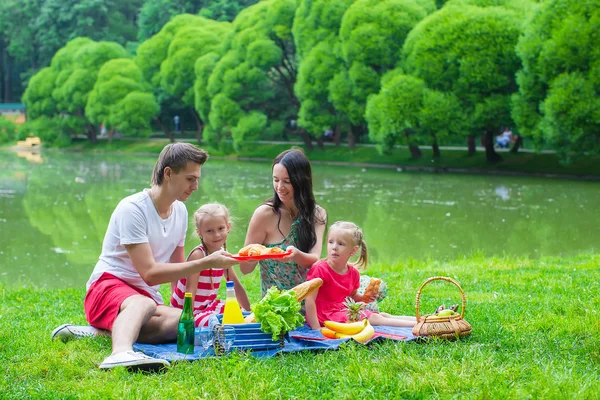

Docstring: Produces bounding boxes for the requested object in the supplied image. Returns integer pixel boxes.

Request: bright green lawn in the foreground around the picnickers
[0,254,600,399]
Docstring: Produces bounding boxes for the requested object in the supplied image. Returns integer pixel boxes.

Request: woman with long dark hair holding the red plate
[240,148,327,296]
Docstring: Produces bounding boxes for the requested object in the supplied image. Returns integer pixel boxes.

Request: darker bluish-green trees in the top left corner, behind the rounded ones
[0,0,143,101]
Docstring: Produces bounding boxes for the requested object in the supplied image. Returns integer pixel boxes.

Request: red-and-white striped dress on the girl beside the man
[171,245,225,327]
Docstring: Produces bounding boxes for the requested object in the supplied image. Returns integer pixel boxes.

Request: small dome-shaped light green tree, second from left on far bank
[85,58,160,139]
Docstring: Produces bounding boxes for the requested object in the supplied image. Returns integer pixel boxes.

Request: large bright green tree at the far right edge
[512,0,600,160]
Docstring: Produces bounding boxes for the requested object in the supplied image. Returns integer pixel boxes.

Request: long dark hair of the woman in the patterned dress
[265,148,327,252]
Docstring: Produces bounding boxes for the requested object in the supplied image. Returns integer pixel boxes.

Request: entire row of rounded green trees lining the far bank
[15,0,600,161]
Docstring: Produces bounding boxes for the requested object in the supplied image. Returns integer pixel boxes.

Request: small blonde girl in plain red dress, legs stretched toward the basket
[306,221,417,329]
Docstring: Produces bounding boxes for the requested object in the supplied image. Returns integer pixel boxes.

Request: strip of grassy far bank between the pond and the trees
[49,140,600,178]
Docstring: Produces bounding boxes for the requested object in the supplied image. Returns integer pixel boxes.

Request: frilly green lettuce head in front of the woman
[252,286,304,340]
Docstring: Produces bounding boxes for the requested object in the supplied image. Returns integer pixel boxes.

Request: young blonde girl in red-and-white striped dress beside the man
[171,203,250,327]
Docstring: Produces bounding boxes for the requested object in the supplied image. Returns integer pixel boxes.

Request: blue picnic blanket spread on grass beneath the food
[133,325,415,361]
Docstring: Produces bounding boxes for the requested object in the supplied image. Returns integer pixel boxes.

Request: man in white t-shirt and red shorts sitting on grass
[52,143,237,370]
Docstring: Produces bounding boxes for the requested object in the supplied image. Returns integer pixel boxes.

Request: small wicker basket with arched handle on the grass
[413,276,472,340]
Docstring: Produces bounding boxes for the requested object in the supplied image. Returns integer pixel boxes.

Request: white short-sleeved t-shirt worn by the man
[86,189,188,304]
